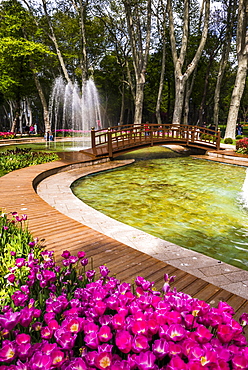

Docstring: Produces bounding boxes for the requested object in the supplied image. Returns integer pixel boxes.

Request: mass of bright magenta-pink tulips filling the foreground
[0,238,248,370]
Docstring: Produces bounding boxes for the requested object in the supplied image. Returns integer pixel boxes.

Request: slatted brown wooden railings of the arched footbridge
[91,123,220,155]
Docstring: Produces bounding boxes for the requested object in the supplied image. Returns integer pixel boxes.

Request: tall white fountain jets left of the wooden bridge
[49,77,101,150]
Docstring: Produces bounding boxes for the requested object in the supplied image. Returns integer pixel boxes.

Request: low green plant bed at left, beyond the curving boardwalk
[0,148,59,173]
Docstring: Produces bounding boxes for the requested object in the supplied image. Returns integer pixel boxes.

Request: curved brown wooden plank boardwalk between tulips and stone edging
[0,155,248,326]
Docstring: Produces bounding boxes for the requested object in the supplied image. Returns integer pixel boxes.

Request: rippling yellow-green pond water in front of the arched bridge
[72,147,248,270]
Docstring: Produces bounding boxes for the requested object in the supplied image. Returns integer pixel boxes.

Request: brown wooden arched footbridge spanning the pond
[82,124,220,158]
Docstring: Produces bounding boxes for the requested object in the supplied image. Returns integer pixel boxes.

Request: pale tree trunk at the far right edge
[225,0,248,139]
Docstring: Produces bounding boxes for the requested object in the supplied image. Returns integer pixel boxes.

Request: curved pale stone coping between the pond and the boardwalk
[36,160,248,299]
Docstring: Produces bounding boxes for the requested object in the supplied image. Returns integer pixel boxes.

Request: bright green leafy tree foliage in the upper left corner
[0,0,53,101]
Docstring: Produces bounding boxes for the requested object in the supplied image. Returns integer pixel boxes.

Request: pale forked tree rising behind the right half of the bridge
[168,0,210,125]
